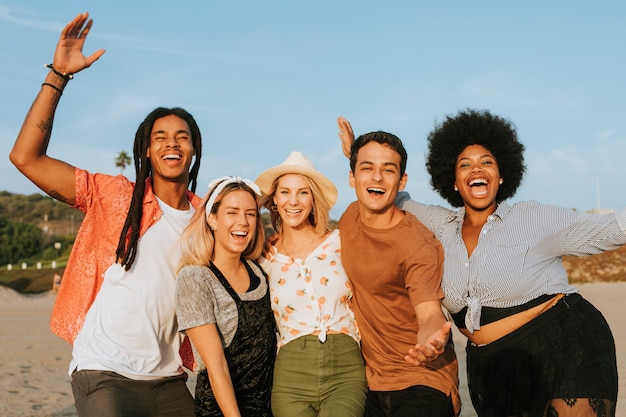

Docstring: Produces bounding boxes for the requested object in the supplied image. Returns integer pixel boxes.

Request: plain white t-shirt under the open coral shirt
[69,200,194,379]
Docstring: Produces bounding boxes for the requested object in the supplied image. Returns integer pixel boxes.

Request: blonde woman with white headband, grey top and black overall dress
[176,177,276,417]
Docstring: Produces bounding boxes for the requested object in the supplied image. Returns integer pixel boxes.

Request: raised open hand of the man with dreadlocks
[52,13,105,74]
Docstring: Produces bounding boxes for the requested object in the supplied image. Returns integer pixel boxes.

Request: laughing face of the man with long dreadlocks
[146,115,194,186]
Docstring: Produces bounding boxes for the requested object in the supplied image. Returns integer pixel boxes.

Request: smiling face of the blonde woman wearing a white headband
[207,189,258,257]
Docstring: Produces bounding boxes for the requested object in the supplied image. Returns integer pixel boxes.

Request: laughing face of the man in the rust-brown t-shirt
[350,141,407,214]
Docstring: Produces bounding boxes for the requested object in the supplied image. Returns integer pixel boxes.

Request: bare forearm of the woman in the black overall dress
[185,324,241,417]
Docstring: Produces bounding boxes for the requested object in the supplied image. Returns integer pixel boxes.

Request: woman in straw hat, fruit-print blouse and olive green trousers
[256,152,367,417]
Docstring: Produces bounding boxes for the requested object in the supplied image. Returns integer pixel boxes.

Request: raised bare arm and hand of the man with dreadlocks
[9,13,104,204]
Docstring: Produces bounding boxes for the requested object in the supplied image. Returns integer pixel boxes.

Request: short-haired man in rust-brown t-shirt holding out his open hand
[339,132,460,417]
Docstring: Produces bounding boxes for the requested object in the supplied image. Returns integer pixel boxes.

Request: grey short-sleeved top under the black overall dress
[176,261,267,369]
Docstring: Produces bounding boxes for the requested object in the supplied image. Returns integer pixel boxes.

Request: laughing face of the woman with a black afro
[454,145,502,212]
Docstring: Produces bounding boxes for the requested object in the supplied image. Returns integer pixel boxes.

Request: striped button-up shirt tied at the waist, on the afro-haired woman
[396,192,626,332]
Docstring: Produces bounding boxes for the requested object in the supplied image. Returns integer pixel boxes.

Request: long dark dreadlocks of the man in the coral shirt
[115,107,202,271]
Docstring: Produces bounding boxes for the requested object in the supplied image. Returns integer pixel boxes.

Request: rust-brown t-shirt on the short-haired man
[339,202,460,412]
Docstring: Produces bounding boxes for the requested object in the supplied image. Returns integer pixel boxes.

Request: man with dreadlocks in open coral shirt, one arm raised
[10,13,202,417]
